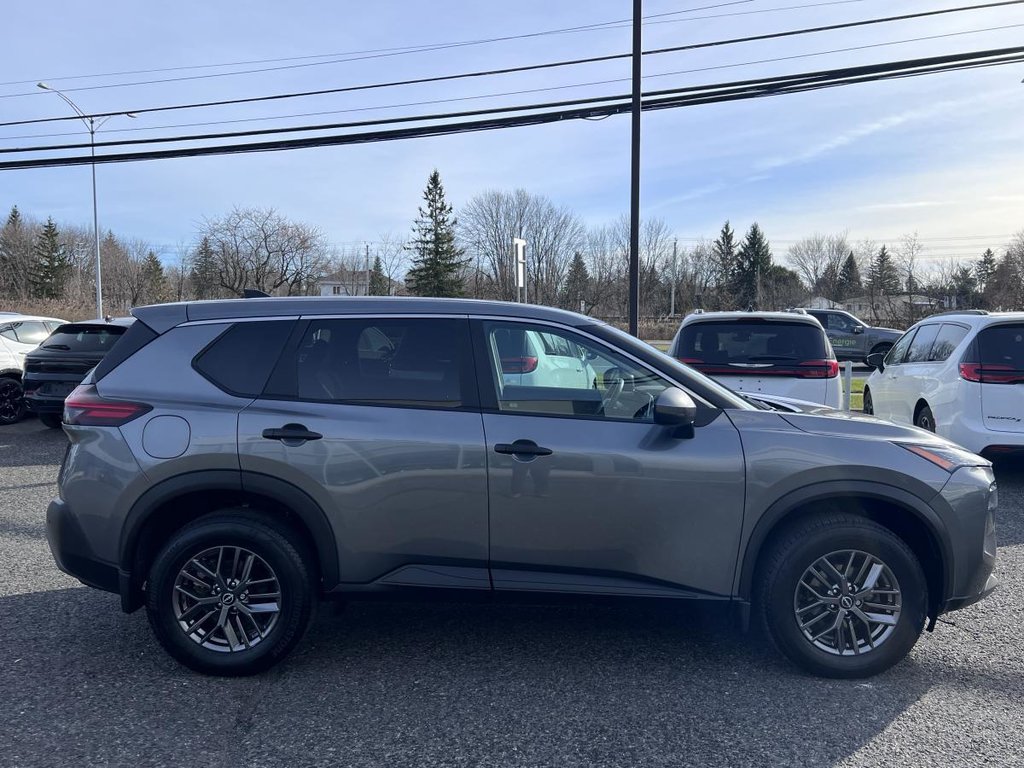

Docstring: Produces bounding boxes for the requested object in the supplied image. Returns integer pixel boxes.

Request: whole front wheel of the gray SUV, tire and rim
[757,514,928,678]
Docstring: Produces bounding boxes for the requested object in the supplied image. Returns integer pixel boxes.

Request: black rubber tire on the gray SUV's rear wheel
[146,509,316,677]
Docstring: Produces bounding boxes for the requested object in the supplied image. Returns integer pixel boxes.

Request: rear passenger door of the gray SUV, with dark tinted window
[239,317,489,589]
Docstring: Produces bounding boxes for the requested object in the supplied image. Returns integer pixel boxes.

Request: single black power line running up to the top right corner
[0,0,1024,127]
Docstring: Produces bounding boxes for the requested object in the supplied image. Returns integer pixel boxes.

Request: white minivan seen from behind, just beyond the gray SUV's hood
[669,312,843,409]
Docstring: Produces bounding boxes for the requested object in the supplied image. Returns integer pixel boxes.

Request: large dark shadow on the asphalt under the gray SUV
[0,588,934,766]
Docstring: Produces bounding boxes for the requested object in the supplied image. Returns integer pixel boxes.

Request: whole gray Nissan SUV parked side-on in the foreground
[46,298,996,677]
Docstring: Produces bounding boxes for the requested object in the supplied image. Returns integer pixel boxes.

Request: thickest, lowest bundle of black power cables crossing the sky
[0,47,1024,170]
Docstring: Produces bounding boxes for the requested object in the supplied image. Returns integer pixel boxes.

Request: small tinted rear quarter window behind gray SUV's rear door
[192,321,295,397]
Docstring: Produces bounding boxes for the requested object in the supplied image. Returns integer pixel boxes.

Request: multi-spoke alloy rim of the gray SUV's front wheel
[793,550,902,656]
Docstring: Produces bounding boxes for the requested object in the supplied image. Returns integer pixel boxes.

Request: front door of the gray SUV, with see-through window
[474,321,744,597]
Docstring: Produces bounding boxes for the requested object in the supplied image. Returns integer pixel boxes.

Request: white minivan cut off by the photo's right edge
[864,310,1024,453]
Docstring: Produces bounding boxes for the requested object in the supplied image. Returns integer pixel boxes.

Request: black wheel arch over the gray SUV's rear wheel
[118,470,339,612]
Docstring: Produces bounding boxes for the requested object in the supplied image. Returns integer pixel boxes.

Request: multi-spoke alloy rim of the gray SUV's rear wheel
[172,546,282,652]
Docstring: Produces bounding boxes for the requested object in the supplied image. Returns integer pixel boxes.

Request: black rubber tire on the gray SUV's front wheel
[755,513,928,678]
